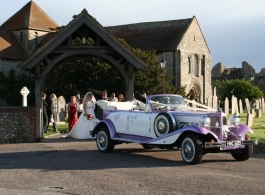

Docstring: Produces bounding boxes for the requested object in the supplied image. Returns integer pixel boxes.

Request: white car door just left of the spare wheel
[128,111,151,136]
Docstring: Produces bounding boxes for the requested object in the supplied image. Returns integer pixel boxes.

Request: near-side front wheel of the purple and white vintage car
[181,134,204,165]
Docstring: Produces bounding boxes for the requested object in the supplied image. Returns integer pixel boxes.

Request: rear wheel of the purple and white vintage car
[96,128,115,153]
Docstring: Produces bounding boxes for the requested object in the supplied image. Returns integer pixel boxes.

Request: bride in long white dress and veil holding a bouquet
[65,92,96,139]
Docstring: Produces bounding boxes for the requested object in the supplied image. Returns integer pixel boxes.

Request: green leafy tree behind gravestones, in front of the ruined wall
[214,79,263,102]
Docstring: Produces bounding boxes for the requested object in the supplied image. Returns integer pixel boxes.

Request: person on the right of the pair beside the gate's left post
[47,93,59,132]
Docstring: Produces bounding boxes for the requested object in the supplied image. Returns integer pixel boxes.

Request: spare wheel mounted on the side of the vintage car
[154,113,173,137]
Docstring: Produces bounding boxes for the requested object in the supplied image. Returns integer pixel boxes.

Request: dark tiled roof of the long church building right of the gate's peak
[105,18,193,51]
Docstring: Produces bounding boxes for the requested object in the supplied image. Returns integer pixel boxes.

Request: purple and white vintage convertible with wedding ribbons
[91,94,257,164]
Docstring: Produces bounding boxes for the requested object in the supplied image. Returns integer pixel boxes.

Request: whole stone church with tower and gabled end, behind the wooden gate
[0,1,212,104]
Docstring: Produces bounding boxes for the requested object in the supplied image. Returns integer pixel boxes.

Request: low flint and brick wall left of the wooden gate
[0,106,36,143]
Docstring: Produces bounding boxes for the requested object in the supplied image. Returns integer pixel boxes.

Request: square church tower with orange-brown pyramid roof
[0,1,59,56]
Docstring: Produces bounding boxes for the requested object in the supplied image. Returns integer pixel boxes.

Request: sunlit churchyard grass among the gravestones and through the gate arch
[44,112,265,142]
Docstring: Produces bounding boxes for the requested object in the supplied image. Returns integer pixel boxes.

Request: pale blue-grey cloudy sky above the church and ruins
[0,0,265,73]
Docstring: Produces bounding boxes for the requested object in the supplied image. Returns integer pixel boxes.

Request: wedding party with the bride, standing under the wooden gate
[42,89,127,139]
